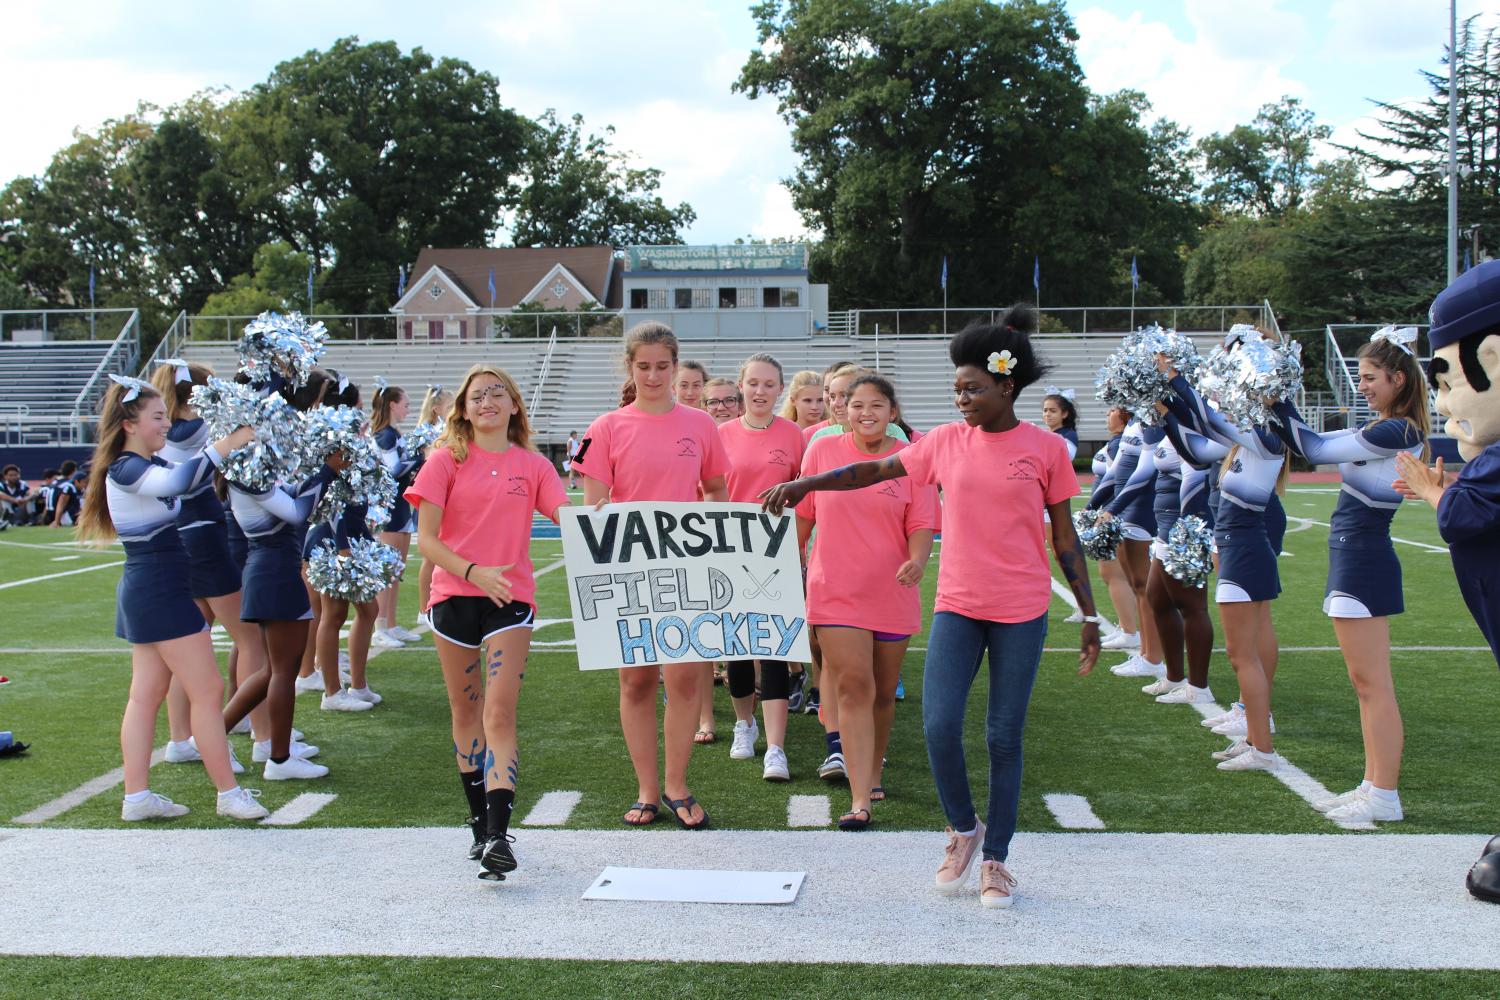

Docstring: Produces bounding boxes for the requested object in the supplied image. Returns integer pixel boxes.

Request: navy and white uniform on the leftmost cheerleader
[105,450,219,643]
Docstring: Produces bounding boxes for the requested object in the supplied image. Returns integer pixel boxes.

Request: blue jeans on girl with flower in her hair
[923,612,1047,861]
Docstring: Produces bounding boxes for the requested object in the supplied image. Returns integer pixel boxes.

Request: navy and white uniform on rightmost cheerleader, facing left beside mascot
[1275,402,1422,618]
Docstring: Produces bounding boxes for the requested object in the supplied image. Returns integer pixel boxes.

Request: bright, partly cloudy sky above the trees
[0,0,1500,243]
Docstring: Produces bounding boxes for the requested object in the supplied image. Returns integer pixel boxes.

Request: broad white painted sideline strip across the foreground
[0,827,1500,969]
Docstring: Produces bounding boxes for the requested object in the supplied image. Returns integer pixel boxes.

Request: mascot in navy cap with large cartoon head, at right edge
[1397,261,1500,903]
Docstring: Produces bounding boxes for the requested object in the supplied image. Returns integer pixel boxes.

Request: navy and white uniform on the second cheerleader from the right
[1167,375,1286,604]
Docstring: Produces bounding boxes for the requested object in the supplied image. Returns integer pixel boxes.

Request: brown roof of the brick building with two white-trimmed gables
[411,246,621,309]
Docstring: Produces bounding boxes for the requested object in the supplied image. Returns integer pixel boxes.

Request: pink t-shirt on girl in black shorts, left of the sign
[405,442,567,610]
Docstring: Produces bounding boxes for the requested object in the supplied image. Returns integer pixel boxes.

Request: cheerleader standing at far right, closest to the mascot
[1274,328,1428,823]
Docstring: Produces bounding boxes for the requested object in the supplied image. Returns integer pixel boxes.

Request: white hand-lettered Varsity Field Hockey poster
[563,502,812,670]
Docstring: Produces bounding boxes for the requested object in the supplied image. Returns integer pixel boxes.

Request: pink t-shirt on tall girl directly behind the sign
[573,405,729,504]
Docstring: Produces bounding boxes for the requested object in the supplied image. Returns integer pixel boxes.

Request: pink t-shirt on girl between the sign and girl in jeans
[797,435,939,636]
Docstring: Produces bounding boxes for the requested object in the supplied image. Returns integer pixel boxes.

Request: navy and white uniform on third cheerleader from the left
[230,466,335,622]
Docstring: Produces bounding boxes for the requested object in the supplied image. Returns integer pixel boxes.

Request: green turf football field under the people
[0,486,1500,996]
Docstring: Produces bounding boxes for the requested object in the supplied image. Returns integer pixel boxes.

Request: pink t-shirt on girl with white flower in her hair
[902,421,1079,622]
